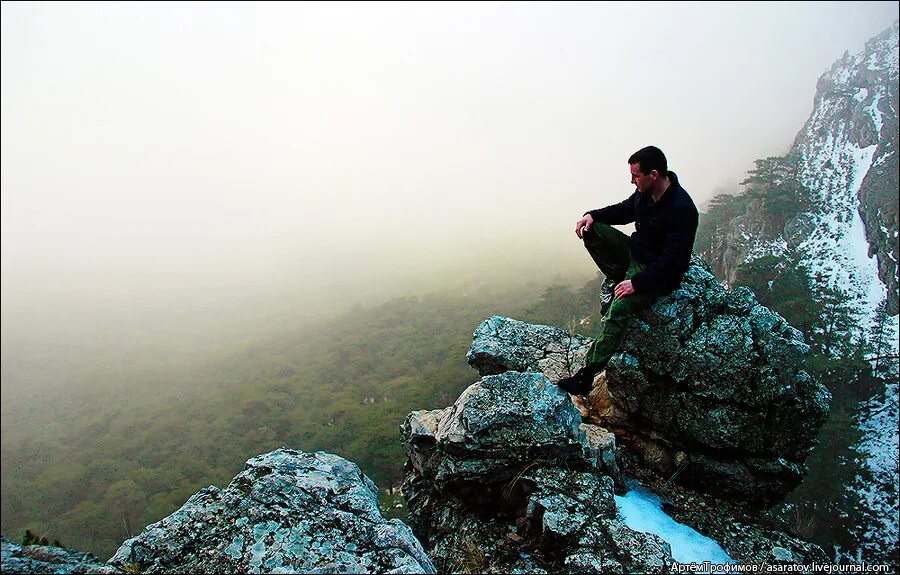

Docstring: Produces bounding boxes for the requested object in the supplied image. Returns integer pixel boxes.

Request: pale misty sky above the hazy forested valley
[2,2,898,322]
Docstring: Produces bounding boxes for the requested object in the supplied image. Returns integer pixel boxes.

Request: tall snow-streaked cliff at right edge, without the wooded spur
[794,23,898,315]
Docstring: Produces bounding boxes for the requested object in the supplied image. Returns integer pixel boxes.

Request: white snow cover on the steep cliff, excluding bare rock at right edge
[794,24,898,337]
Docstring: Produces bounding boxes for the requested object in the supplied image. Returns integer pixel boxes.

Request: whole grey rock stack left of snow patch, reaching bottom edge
[401,372,671,573]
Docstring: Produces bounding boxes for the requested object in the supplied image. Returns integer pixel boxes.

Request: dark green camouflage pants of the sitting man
[584,223,658,372]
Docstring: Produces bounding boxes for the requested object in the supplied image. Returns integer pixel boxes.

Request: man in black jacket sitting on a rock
[557,146,698,395]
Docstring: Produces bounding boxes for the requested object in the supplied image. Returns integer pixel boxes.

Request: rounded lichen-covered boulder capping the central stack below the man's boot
[401,372,618,498]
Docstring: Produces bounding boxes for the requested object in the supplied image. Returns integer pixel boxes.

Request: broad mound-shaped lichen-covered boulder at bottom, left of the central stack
[109,448,435,573]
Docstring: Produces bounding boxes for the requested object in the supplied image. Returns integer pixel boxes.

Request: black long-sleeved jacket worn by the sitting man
[585,172,698,294]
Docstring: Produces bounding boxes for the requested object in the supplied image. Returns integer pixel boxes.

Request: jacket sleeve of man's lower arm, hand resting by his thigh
[631,206,699,293]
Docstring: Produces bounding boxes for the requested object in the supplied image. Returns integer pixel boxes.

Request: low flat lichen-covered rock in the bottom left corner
[0,537,122,573]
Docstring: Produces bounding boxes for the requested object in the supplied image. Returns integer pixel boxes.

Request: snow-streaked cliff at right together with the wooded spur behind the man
[702,23,898,317]
